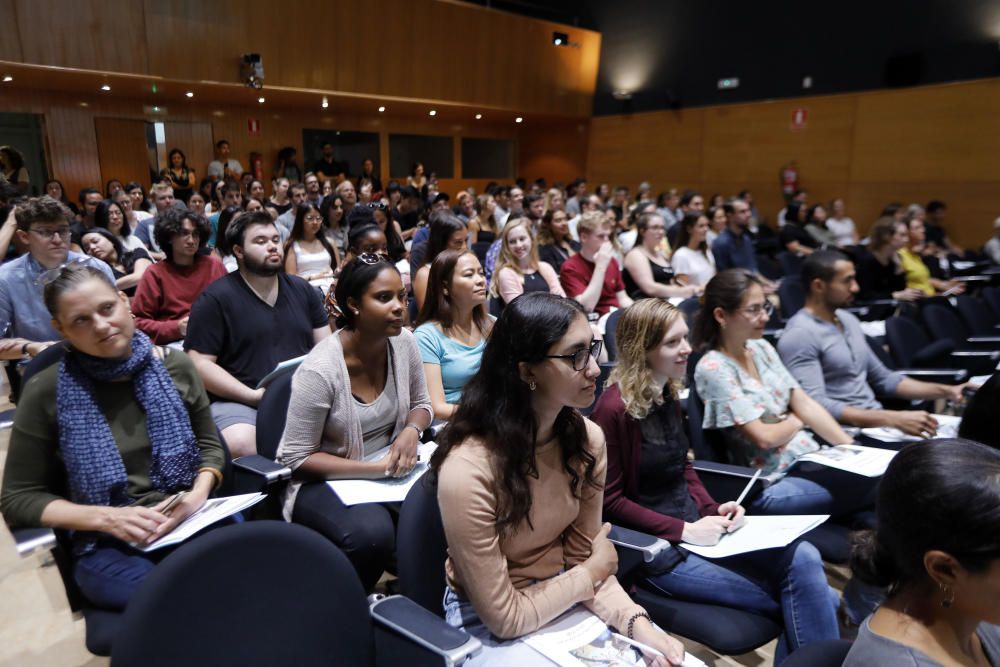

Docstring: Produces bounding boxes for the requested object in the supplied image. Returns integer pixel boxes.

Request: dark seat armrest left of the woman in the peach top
[369,595,482,666]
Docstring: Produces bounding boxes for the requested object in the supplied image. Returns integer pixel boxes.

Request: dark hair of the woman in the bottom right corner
[851,439,1000,596]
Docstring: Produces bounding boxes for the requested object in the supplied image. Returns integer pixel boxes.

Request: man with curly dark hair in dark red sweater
[132,208,226,345]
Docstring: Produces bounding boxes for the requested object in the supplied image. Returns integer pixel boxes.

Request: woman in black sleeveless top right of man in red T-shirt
[623,213,704,299]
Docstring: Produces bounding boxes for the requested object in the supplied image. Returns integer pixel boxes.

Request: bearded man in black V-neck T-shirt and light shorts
[184,211,330,457]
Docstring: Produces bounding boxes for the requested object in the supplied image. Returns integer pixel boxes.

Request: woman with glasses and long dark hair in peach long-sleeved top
[431,292,684,666]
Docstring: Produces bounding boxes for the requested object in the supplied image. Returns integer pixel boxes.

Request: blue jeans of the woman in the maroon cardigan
[648,541,840,665]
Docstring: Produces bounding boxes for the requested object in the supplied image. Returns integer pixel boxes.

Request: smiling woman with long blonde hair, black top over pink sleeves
[490,218,566,304]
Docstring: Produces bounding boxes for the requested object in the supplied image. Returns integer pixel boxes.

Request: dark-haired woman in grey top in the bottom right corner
[844,440,1000,667]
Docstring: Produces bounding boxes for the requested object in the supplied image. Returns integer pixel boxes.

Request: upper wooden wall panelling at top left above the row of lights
[0,0,600,117]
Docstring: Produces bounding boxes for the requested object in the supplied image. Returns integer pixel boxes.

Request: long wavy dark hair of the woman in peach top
[431,292,600,536]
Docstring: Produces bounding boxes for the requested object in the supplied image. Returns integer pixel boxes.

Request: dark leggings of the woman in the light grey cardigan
[292,482,396,591]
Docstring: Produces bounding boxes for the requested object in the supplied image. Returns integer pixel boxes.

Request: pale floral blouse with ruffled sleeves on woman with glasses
[694,340,819,475]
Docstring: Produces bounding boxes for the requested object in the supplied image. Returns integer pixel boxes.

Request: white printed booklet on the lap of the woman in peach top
[521,605,705,667]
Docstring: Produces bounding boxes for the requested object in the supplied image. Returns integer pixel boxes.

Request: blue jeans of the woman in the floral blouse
[749,464,881,517]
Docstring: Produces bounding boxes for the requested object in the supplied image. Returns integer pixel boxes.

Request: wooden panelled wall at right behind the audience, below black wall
[587,79,1000,247]
